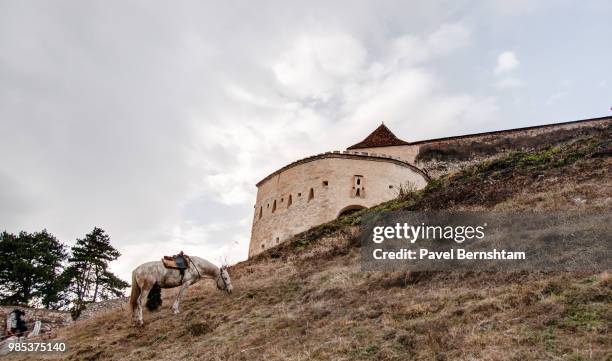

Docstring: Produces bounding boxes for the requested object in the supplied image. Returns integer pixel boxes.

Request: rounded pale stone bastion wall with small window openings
[249,154,427,257]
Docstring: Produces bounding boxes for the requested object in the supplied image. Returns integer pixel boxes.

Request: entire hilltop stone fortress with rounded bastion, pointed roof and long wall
[249,117,612,257]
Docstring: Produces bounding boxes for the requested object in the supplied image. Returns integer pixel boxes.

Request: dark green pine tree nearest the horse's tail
[66,227,129,314]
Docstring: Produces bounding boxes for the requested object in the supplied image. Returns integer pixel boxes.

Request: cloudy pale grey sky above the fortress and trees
[0,0,612,279]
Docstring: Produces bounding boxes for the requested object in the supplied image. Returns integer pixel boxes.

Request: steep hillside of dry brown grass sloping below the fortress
[10,124,612,360]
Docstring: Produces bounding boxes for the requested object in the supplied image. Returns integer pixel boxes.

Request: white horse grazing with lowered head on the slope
[130,257,233,326]
